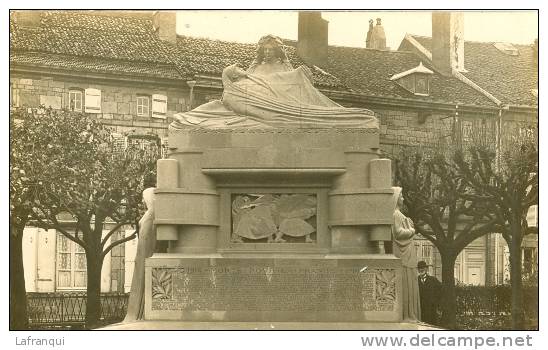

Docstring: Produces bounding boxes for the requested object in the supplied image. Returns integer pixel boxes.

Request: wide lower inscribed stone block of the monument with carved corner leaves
[145,254,401,322]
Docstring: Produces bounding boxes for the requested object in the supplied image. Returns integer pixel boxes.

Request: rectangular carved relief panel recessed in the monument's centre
[232,193,317,243]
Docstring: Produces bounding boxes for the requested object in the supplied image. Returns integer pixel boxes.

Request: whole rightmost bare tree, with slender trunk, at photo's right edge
[455,126,538,329]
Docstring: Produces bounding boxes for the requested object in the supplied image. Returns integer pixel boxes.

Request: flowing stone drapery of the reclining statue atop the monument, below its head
[170,66,378,129]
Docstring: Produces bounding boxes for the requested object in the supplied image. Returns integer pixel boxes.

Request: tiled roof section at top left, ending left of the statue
[10,11,187,79]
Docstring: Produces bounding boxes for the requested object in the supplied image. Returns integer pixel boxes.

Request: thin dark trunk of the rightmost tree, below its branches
[510,218,524,330]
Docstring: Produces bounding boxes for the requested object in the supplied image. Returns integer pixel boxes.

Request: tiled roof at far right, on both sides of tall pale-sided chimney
[404,35,538,106]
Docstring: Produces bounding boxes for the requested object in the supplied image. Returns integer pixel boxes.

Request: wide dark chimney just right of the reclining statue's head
[297,11,329,67]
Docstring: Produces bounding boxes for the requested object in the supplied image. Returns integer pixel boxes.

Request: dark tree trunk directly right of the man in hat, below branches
[440,250,457,329]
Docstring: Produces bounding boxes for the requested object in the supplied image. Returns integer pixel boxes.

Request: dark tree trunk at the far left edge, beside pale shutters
[9,225,29,330]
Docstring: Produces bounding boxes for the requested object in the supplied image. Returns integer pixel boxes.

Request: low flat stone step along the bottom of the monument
[100,320,440,331]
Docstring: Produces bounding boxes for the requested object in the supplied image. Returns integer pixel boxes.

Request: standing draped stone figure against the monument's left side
[124,187,156,322]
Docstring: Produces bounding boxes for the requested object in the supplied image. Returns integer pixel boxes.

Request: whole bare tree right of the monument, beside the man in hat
[395,146,496,328]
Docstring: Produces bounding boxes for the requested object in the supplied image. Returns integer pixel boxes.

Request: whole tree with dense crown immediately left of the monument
[12,109,159,328]
